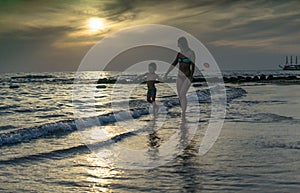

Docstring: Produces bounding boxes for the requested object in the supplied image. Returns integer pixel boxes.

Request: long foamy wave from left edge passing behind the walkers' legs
[0,87,246,147]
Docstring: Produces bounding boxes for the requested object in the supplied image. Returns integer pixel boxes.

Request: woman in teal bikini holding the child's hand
[164,37,195,118]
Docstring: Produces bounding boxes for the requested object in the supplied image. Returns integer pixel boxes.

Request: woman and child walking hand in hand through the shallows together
[139,37,195,119]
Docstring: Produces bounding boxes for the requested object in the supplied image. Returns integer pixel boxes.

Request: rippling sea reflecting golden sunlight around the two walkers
[0,70,300,193]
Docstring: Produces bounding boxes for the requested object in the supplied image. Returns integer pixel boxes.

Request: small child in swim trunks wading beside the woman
[139,62,161,116]
